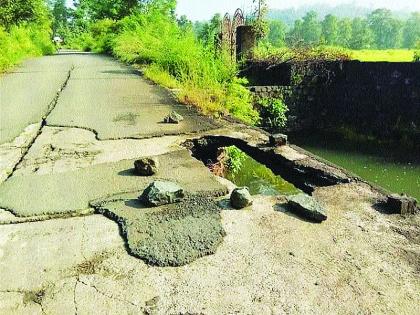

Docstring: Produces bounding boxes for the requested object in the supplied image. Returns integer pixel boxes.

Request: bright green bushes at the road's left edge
[0,24,55,72]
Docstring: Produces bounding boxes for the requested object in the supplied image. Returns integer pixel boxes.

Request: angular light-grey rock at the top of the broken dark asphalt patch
[139,181,185,207]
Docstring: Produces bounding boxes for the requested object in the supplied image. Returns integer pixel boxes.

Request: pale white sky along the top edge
[177,0,420,20]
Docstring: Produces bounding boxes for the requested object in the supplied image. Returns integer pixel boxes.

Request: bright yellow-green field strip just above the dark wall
[351,49,414,62]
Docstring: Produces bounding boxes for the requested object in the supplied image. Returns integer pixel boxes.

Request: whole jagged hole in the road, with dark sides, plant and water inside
[183,136,349,195]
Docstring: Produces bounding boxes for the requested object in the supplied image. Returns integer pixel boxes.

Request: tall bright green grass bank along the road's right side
[73,5,259,124]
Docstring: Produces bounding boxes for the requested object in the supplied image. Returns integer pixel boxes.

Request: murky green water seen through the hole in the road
[224,149,300,196]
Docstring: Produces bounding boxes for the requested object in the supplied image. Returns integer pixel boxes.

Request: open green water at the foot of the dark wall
[291,134,420,200]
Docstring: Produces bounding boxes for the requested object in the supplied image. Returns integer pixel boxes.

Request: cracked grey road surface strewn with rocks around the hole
[0,52,420,315]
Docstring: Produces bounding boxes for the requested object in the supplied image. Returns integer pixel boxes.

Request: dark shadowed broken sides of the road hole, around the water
[183,136,351,195]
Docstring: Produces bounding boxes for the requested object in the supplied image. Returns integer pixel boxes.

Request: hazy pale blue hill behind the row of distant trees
[268,4,410,26]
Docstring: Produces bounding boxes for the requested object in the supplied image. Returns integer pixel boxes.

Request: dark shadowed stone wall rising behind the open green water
[246,62,420,145]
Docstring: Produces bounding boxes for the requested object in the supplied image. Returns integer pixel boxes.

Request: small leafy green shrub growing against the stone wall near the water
[257,98,289,130]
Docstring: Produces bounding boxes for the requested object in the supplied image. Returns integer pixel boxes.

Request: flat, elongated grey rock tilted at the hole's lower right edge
[287,194,327,222]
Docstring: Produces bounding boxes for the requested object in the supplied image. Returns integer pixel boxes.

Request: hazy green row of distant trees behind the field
[267,9,420,49]
